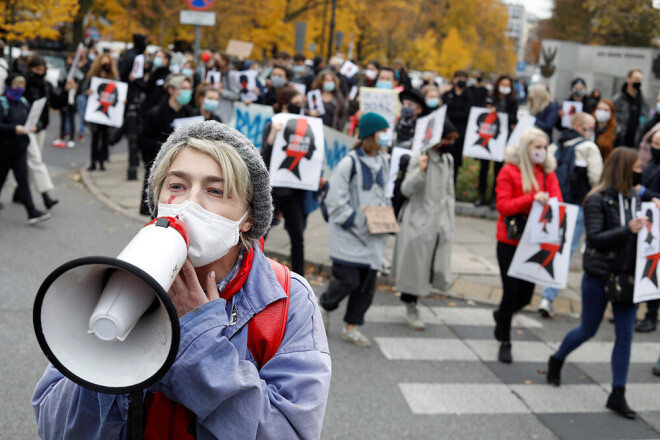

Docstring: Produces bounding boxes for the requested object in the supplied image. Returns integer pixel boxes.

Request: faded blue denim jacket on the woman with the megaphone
[32,249,331,440]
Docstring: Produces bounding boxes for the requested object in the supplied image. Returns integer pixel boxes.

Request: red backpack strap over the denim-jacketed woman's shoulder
[248,258,291,370]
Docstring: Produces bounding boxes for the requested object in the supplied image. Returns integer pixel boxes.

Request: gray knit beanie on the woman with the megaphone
[147,121,273,240]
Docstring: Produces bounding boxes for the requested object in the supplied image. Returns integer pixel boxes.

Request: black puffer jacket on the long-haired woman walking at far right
[582,188,640,279]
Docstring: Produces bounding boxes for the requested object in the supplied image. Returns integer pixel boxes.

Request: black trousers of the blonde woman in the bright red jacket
[495,241,534,342]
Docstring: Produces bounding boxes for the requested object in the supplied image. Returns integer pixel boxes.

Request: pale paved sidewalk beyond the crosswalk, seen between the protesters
[80,154,582,317]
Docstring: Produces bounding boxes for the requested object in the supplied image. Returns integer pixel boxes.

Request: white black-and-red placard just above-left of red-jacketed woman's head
[463,107,509,162]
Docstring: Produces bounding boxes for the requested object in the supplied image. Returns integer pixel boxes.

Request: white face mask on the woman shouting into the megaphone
[158,200,248,267]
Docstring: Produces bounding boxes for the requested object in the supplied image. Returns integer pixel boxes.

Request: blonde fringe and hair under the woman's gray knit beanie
[151,138,254,249]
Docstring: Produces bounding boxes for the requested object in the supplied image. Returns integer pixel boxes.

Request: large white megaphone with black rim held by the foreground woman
[33,217,190,394]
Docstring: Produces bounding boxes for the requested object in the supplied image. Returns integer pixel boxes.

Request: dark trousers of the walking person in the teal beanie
[319,262,377,325]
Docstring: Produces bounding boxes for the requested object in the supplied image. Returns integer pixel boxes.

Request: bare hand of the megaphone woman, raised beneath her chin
[168,258,220,318]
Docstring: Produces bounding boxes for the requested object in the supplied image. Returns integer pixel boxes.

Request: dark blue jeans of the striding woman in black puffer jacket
[555,274,637,387]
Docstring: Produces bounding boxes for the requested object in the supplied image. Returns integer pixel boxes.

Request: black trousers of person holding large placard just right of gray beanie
[275,190,305,276]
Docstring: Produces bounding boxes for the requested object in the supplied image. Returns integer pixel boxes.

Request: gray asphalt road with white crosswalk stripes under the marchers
[0,116,660,440]
